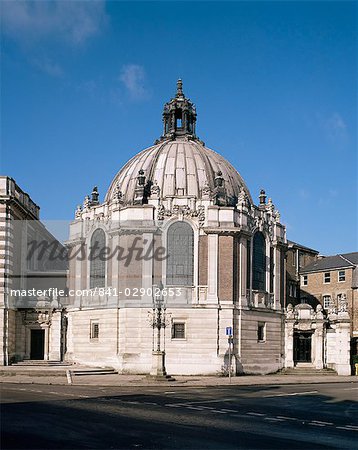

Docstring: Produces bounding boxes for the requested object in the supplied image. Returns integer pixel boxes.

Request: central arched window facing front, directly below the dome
[167,222,194,286]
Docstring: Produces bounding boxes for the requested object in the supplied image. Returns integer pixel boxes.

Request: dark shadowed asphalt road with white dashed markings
[1,383,358,449]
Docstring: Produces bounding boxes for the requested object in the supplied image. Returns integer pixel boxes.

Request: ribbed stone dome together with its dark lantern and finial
[106,80,252,206]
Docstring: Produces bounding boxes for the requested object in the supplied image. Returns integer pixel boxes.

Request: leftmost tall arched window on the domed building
[89,228,106,289]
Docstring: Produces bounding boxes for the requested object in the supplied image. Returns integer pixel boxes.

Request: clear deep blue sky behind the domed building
[1,1,358,254]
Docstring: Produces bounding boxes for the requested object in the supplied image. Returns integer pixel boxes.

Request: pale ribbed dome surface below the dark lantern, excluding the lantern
[106,136,252,206]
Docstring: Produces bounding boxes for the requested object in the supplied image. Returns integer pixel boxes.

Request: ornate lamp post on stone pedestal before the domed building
[148,282,169,379]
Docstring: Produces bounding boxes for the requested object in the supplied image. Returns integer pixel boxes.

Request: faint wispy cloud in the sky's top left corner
[1,0,107,45]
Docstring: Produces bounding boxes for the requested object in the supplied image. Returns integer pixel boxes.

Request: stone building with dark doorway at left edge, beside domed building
[0,176,67,365]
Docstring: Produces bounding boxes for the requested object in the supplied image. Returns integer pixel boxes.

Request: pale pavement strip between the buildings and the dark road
[0,368,358,386]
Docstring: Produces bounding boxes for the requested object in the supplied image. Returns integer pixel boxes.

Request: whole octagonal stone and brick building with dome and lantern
[65,80,286,374]
